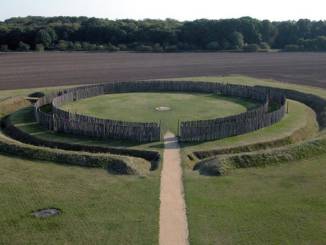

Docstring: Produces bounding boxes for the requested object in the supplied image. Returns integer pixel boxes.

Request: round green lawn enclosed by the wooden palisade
[63,92,256,133]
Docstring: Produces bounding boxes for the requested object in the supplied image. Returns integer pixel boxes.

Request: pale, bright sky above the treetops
[0,0,326,21]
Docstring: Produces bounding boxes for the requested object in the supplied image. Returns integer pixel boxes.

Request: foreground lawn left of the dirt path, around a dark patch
[0,156,159,245]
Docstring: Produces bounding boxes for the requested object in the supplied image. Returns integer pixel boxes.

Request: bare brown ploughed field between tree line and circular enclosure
[0,52,326,90]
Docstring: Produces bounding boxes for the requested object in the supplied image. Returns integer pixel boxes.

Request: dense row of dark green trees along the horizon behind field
[0,17,326,52]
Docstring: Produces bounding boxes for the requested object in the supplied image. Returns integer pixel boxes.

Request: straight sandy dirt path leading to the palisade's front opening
[159,133,189,245]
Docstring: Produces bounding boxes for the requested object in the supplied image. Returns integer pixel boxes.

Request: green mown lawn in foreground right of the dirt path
[184,155,326,244]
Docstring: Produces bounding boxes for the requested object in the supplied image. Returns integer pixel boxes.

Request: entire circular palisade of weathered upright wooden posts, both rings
[35,81,285,142]
